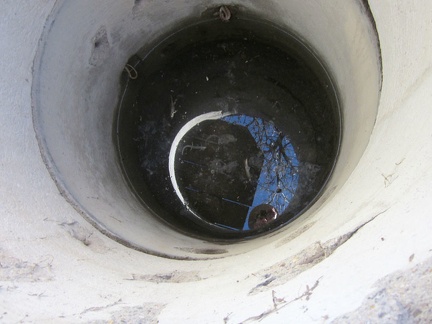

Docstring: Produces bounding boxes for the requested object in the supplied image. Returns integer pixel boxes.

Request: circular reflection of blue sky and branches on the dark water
[170,114,299,231]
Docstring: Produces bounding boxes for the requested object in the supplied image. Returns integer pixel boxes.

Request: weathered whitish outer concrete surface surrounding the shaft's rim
[0,0,432,323]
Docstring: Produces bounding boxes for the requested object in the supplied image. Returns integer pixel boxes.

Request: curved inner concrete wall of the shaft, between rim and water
[32,0,381,259]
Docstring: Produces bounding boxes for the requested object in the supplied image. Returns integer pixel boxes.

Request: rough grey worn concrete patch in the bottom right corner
[332,258,432,324]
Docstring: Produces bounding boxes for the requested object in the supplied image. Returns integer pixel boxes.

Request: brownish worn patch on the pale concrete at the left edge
[0,251,54,282]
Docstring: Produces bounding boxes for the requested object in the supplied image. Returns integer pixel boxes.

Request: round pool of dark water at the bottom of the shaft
[115,13,340,239]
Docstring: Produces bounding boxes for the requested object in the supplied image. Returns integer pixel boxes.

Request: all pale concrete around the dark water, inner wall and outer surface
[0,0,432,323]
